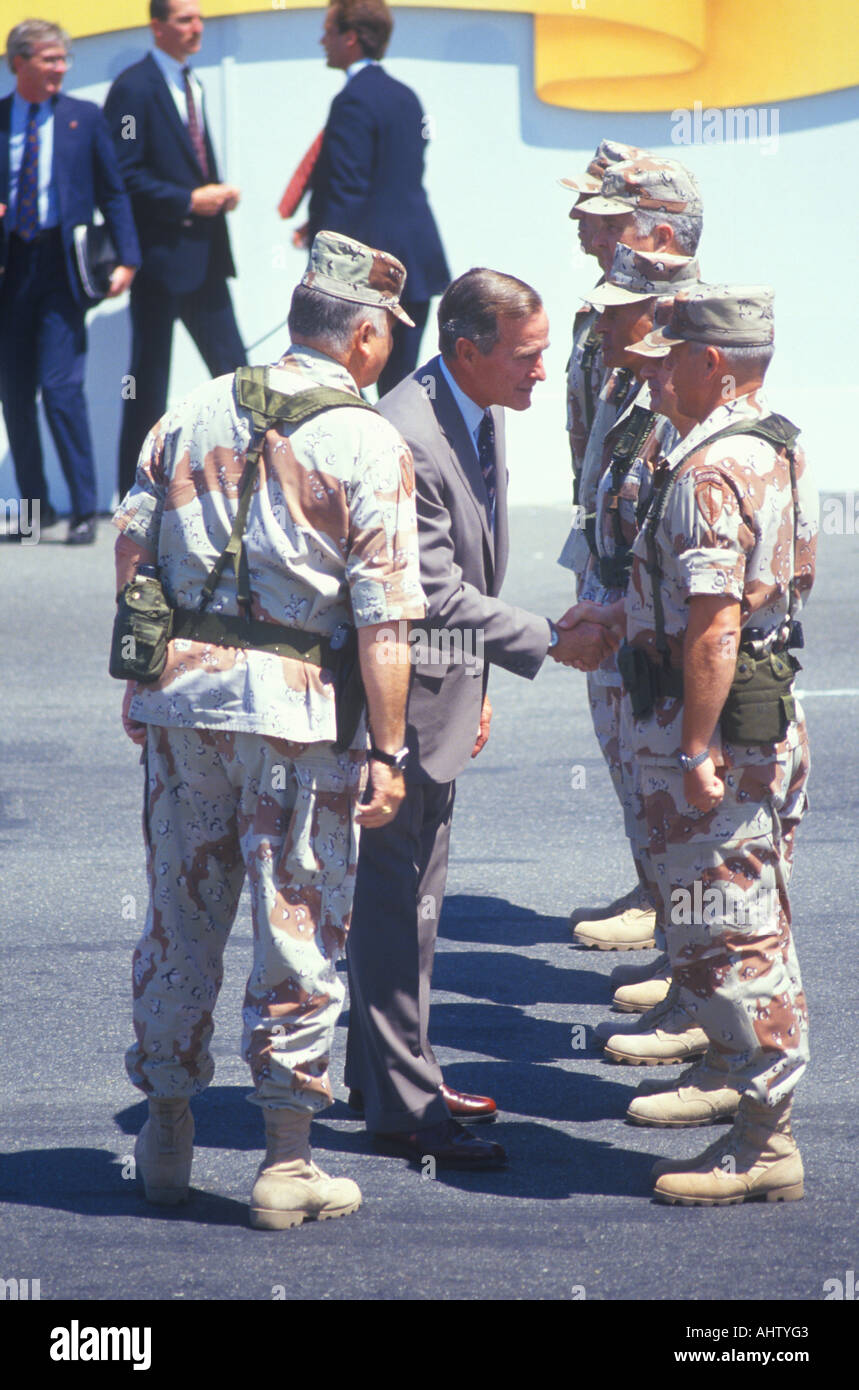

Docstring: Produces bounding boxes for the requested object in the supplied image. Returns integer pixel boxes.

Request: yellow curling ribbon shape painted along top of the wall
[0,0,859,111]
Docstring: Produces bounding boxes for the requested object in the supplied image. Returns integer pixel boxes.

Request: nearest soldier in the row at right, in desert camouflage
[572,285,817,1205]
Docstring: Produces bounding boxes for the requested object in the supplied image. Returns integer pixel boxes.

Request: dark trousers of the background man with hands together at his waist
[120,264,247,498]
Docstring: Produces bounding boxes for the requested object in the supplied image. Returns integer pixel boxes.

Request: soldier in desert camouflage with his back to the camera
[114,232,425,1229]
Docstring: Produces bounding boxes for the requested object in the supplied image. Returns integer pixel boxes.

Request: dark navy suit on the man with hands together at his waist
[104,54,246,495]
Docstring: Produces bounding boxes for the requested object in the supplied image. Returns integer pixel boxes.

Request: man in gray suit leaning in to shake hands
[346,270,613,1168]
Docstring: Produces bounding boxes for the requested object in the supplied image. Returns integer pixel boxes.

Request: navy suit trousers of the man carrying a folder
[0,231,96,518]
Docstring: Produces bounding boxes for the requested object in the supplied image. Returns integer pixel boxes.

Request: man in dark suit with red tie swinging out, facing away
[295,0,450,395]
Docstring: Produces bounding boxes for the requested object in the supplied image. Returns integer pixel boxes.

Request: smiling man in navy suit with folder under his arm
[0,19,140,545]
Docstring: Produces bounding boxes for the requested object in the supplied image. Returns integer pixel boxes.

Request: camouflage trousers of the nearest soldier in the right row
[635,702,809,1105]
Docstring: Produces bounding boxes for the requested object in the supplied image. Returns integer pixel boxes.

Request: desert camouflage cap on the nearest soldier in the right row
[635,285,774,357]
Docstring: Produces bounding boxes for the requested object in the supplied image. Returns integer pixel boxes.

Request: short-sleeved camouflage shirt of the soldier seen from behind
[114,348,425,746]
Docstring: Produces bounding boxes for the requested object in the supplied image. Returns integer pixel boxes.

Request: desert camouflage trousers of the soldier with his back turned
[125,724,364,1112]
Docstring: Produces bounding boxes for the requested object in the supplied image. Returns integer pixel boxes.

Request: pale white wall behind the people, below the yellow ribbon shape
[0,10,859,507]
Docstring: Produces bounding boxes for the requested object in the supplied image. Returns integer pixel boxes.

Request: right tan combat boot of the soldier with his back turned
[250,1106,361,1230]
